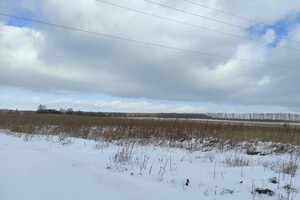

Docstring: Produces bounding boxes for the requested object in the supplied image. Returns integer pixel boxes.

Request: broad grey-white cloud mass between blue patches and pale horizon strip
[0,0,300,110]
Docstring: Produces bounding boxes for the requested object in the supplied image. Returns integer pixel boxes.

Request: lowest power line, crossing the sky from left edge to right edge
[0,12,300,70]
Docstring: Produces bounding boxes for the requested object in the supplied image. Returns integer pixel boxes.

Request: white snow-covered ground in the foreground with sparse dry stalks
[0,131,300,200]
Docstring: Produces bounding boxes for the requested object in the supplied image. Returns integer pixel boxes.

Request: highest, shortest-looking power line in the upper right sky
[181,0,300,34]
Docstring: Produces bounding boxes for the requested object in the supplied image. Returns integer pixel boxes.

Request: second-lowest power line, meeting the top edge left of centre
[95,0,300,51]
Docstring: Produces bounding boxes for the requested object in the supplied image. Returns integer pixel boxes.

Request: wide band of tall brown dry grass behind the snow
[0,114,300,145]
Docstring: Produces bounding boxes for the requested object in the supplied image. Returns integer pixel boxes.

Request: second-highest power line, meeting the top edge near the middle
[142,0,300,43]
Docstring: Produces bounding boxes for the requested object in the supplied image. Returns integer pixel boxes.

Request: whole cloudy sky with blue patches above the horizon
[0,0,300,113]
